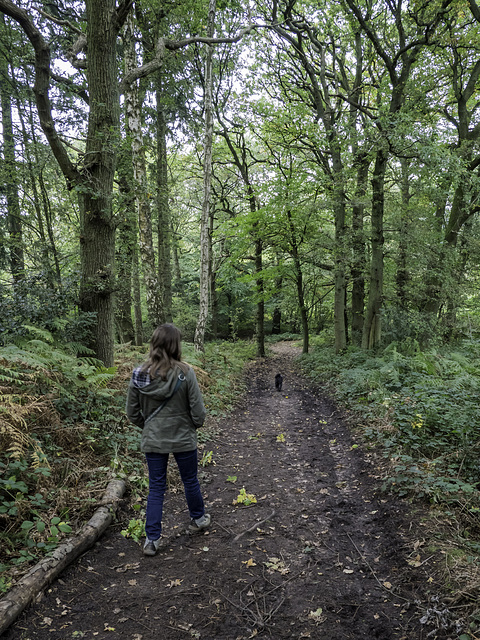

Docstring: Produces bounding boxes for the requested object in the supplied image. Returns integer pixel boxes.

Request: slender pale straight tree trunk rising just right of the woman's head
[194,0,216,351]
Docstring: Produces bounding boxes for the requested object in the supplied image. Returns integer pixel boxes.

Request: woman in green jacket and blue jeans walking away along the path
[126,324,210,556]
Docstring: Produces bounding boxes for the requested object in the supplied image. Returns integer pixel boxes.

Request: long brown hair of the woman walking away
[142,324,188,378]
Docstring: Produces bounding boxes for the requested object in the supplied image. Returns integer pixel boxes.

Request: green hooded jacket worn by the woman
[126,366,206,453]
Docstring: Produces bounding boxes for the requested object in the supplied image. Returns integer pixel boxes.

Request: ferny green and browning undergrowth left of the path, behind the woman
[0,327,255,594]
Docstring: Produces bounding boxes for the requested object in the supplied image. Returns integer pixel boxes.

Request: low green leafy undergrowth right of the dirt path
[301,339,480,512]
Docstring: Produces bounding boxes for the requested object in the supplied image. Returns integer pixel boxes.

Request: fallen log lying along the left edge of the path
[0,480,126,635]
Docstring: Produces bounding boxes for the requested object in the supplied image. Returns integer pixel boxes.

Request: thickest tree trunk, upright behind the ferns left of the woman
[79,0,120,367]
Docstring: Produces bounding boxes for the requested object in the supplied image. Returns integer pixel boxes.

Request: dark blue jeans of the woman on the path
[145,449,205,540]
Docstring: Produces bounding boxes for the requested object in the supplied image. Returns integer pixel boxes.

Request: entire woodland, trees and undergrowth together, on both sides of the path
[0,0,480,637]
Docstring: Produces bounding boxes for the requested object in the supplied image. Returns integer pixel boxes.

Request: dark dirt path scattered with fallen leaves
[4,345,449,640]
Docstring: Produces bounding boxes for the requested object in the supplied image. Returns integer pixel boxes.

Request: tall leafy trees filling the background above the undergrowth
[0,0,480,366]
